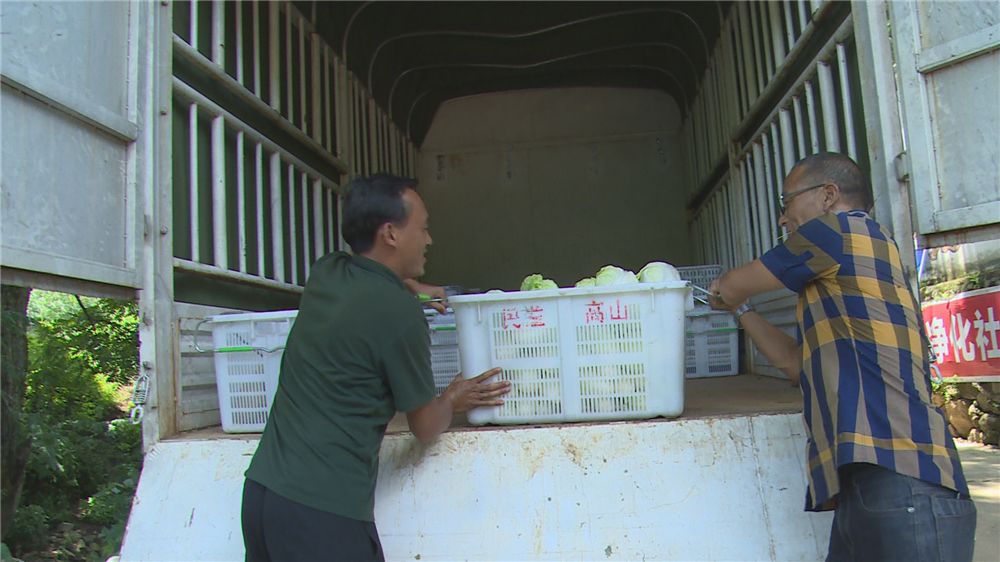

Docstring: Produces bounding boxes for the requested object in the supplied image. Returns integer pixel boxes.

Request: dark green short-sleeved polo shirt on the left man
[246,252,434,521]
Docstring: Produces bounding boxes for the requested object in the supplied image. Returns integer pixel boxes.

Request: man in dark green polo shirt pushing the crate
[242,174,510,561]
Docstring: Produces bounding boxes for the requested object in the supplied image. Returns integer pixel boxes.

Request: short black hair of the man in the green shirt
[342,173,417,254]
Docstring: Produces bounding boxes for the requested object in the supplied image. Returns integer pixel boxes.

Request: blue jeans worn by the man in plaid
[826,463,976,562]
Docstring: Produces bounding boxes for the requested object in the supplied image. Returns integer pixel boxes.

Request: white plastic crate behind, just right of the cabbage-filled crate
[684,311,740,378]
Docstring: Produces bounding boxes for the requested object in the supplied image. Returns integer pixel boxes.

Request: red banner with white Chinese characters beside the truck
[923,287,1000,382]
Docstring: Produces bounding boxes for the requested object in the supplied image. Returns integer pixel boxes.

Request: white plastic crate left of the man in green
[208,310,298,433]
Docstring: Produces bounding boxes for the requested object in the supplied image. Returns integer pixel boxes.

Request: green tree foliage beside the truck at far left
[7,290,142,560]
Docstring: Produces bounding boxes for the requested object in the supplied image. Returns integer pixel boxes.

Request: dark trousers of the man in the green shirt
[242,480,385,562]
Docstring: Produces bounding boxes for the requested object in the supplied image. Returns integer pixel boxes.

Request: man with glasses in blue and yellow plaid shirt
[711,153,976,561]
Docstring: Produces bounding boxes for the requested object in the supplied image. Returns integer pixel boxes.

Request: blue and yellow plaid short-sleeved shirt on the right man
[760,211,968,511]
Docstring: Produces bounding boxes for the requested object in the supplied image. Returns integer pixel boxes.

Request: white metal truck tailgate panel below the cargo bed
[122,414,832,561]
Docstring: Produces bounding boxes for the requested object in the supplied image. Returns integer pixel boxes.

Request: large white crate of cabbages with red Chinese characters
[450,281,691,424]
